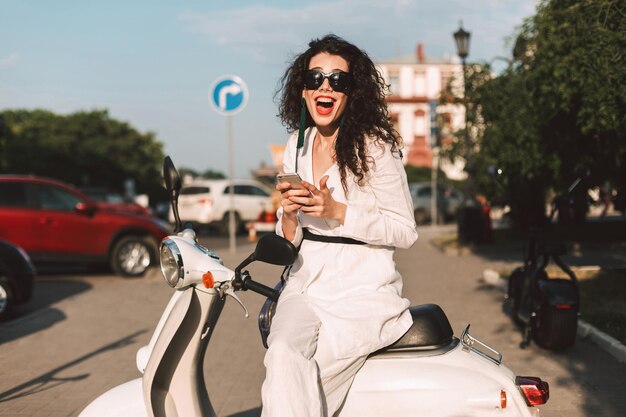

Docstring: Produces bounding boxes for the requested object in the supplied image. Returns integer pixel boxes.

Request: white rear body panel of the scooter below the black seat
[340,344,538,417]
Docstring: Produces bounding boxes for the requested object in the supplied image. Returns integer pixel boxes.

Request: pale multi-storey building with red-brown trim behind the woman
[376,43,465,179]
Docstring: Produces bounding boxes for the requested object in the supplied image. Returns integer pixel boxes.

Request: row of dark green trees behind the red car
[0,110,165,202]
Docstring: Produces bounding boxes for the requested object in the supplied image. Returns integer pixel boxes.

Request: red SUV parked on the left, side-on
[0,175,170,276]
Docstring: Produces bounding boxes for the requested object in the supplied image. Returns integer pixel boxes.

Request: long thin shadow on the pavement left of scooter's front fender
[0,329,148,403]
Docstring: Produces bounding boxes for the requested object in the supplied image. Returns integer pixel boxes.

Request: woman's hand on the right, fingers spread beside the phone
[289,175,346,224]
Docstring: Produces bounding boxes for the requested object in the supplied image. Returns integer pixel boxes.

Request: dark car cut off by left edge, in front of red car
[0,240,35,321]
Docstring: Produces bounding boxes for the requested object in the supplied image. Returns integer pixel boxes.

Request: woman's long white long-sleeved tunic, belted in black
[276,127,417,358]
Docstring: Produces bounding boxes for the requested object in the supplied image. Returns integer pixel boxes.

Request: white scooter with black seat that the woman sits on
[79,157,549,417]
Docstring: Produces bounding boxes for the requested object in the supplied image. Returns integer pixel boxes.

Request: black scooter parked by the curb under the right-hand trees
[506,177,582,350]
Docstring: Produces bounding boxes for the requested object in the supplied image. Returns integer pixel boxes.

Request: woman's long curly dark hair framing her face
[276,34,401,191]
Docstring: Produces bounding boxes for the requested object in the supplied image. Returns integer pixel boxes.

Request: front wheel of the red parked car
[111,236,154,277]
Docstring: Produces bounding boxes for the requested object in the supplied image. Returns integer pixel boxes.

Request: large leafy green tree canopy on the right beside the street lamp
[443,0,626,225]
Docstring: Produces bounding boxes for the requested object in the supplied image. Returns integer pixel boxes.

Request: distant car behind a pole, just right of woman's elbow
[409,182,463,224]
